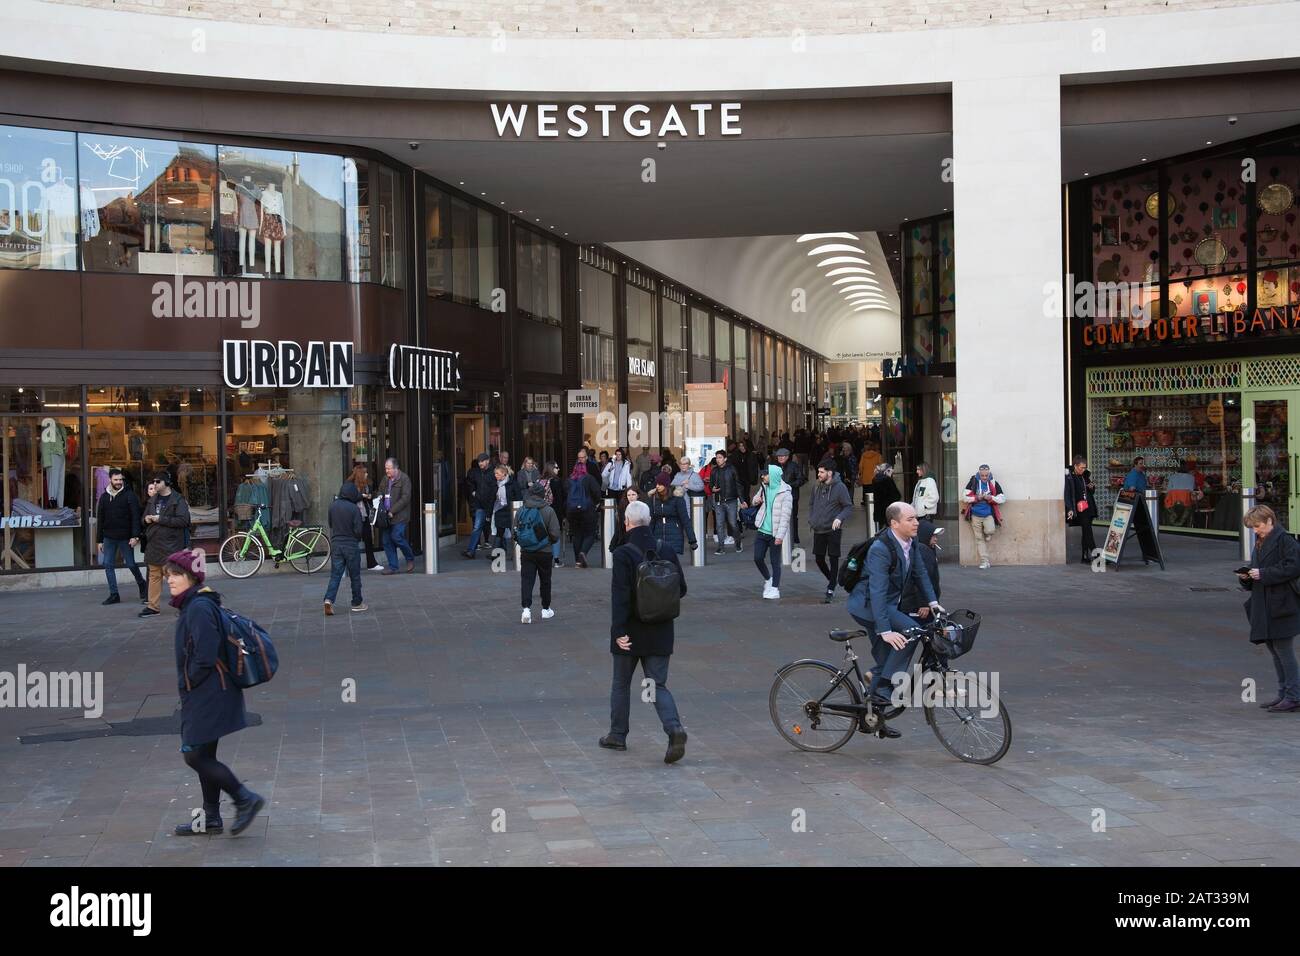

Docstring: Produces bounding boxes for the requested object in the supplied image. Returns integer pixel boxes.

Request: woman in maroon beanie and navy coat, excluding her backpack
[163,551,265,836]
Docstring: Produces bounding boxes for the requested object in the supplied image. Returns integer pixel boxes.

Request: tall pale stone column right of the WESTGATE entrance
[953,73,1066,566]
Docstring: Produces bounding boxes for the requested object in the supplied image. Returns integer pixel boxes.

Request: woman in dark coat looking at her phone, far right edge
[1238,505,1300,714]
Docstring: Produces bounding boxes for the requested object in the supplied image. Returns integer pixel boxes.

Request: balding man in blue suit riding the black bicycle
[848,501,944,737]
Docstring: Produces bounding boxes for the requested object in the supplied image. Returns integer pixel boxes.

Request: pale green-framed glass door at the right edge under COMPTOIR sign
[1242,392,1300,529]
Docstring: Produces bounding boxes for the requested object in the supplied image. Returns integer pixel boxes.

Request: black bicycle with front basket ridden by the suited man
[767,611,1011,763]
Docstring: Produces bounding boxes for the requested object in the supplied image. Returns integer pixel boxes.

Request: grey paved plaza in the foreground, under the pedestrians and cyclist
[0,509,1300,866]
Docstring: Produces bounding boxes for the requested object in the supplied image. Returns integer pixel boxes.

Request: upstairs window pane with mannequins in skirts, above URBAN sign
[220,146,345,280]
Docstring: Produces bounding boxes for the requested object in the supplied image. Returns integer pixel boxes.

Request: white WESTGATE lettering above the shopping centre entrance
[489,103,741,139]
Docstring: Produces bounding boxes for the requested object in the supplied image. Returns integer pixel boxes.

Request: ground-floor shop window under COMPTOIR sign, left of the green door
[1088,392,1237,533]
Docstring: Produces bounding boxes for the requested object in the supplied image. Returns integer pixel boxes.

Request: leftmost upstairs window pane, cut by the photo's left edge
[0,126,79,269]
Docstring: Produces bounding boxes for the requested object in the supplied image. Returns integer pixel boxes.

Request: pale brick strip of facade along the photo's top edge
[47,0,1287,43]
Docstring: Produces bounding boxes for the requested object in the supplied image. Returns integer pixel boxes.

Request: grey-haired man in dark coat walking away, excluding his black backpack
[601,501,686,763]
